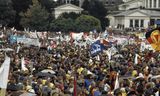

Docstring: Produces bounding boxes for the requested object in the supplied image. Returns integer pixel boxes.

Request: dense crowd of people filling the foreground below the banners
[0,28,160,96]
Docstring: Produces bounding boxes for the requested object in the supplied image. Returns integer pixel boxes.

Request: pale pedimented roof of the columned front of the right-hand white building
[114,8,160,17]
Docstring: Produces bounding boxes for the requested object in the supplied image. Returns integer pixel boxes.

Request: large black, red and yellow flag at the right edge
[146,28,160,51]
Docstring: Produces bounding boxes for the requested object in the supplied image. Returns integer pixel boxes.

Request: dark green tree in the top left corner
[0,0,16,26]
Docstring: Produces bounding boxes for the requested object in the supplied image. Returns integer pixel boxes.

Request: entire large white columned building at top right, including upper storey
[107,0,160,28]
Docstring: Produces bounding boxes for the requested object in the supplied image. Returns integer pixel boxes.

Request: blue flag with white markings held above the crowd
[90,40,105,56]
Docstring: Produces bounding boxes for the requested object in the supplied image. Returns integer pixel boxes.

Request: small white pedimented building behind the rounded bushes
[54,4,83,18]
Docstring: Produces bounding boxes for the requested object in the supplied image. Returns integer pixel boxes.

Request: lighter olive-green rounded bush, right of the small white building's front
[75,15,101,32]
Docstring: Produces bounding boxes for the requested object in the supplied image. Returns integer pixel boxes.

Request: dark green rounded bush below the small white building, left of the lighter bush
[50,17,75,32]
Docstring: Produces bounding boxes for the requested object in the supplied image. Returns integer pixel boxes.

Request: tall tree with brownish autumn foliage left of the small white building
[20,0,49,31]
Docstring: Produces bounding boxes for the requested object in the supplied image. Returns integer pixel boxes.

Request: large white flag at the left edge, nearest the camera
[0,56,10,89]
